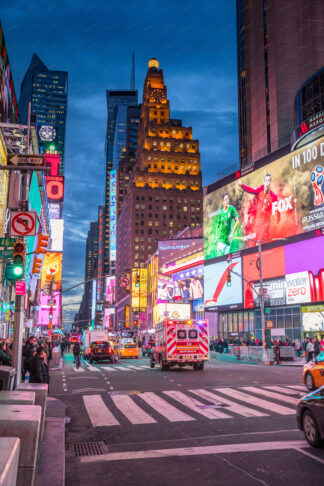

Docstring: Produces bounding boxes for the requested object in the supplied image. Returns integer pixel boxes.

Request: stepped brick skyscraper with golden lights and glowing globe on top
[116,59,202,321]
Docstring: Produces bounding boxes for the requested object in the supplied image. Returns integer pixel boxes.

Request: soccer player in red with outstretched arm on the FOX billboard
[238,174,279,241]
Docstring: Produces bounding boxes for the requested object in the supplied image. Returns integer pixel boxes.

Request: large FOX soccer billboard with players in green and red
[204,138,324,260]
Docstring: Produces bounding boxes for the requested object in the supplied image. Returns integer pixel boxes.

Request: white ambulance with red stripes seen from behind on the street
[151,319,209,371]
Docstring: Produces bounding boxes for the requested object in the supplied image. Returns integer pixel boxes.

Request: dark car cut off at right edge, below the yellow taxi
[297,386,324,447]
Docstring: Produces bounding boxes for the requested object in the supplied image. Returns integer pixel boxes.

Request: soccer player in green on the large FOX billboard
[216,193,240,256]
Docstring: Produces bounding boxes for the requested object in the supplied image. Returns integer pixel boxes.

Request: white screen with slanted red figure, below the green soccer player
[204,258,243,310]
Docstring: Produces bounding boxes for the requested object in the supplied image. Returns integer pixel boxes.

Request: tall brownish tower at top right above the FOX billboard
[236,0,324,167]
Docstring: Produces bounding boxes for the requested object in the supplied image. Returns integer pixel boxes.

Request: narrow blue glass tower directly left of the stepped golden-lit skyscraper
[104,89,138,275]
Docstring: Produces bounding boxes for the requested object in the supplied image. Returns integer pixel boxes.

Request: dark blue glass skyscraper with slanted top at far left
[18,54,68,175]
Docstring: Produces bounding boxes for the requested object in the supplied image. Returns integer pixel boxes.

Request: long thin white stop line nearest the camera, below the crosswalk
[80,440,305,463]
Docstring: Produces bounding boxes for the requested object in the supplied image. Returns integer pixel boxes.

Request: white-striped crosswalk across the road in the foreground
[82,385,306,427]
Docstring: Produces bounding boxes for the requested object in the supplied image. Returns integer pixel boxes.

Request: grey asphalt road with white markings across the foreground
[51,356,324,486]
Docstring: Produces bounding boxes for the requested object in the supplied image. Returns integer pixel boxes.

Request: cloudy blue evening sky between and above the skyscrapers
[0,0,238,322]
